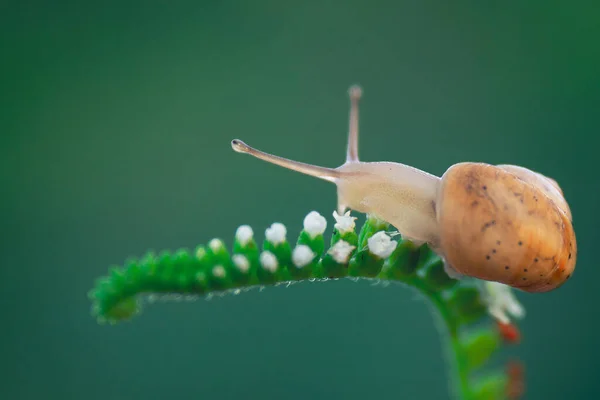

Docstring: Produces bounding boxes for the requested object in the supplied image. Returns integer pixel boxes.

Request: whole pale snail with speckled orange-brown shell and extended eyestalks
[231,86,577,293]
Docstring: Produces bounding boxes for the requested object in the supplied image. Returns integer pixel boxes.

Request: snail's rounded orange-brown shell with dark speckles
[436,163,577,292]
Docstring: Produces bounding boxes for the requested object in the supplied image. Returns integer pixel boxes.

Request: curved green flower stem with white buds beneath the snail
[89,212,520,400]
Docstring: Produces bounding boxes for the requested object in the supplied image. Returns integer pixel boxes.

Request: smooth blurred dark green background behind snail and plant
[0,0,600,400]
